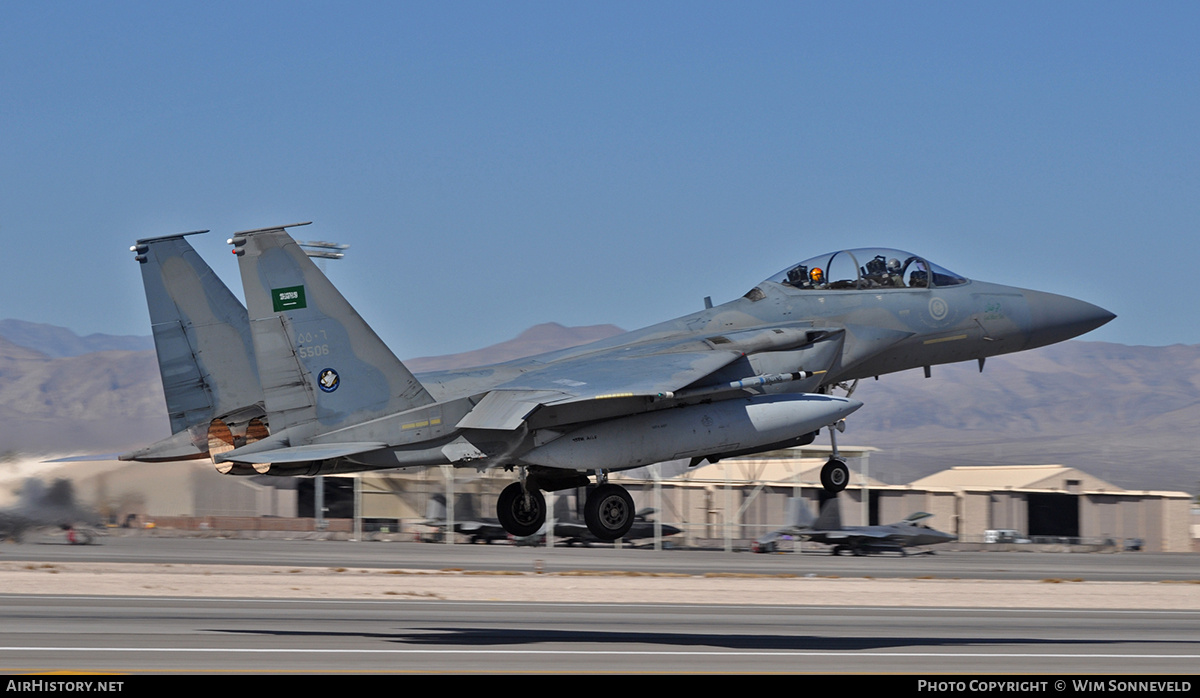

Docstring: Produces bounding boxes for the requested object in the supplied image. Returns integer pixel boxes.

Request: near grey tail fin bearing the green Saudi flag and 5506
[229,223,433,436]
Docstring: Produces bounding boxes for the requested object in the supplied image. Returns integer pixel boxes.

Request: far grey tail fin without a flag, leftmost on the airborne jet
[121,230,266,461]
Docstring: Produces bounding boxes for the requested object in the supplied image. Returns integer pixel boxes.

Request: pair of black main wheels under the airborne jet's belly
[496,473,636,541]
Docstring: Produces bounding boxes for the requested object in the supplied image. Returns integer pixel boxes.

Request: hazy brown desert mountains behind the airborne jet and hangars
[0,320,1200,492]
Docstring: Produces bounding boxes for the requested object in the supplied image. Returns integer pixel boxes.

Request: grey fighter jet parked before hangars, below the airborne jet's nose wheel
[752,497,958,555]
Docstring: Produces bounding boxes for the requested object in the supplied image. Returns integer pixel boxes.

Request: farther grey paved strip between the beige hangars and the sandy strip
[9,535,1200,582]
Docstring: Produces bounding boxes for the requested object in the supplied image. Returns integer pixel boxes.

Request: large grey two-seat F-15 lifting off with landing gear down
[121,223,1114,541]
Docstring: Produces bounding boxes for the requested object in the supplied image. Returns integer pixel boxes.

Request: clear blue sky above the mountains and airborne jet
[0,1,1200,357]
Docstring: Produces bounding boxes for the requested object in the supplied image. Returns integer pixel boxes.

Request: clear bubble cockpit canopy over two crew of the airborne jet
[767,247,967,291]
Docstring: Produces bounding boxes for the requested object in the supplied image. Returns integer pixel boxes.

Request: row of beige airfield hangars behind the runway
[77,446,1194,552]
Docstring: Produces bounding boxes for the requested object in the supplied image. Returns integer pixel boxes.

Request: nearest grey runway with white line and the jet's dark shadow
[0,596,1200,674]
